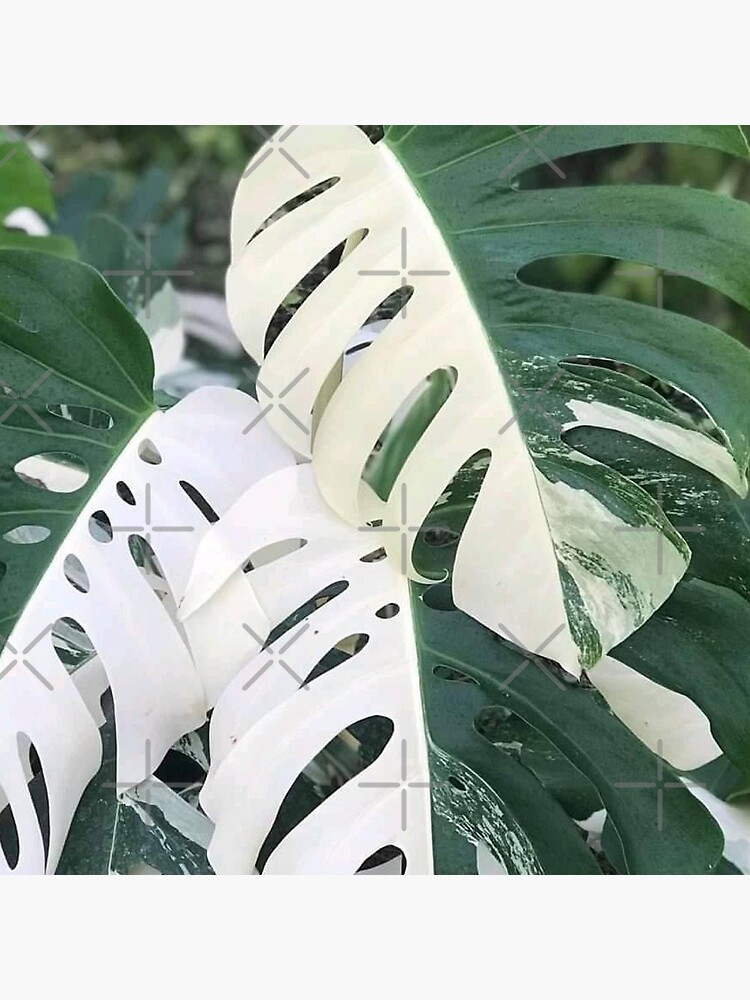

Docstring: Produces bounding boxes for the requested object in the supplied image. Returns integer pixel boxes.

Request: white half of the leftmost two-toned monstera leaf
[0,388,296,874]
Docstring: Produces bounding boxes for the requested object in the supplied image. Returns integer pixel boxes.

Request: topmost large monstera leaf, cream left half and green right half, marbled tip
[228,126,750,675]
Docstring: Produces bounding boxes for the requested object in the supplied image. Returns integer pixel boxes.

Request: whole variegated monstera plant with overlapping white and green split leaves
[0,126,750,874]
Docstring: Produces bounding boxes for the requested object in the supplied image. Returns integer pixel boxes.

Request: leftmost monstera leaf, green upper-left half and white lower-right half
[0,251,291,874]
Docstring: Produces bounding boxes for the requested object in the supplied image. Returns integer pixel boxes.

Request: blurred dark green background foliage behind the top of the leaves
[8,125,750,352]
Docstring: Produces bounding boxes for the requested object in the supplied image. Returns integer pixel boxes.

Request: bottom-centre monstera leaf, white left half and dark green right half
[179,465,748,874]
